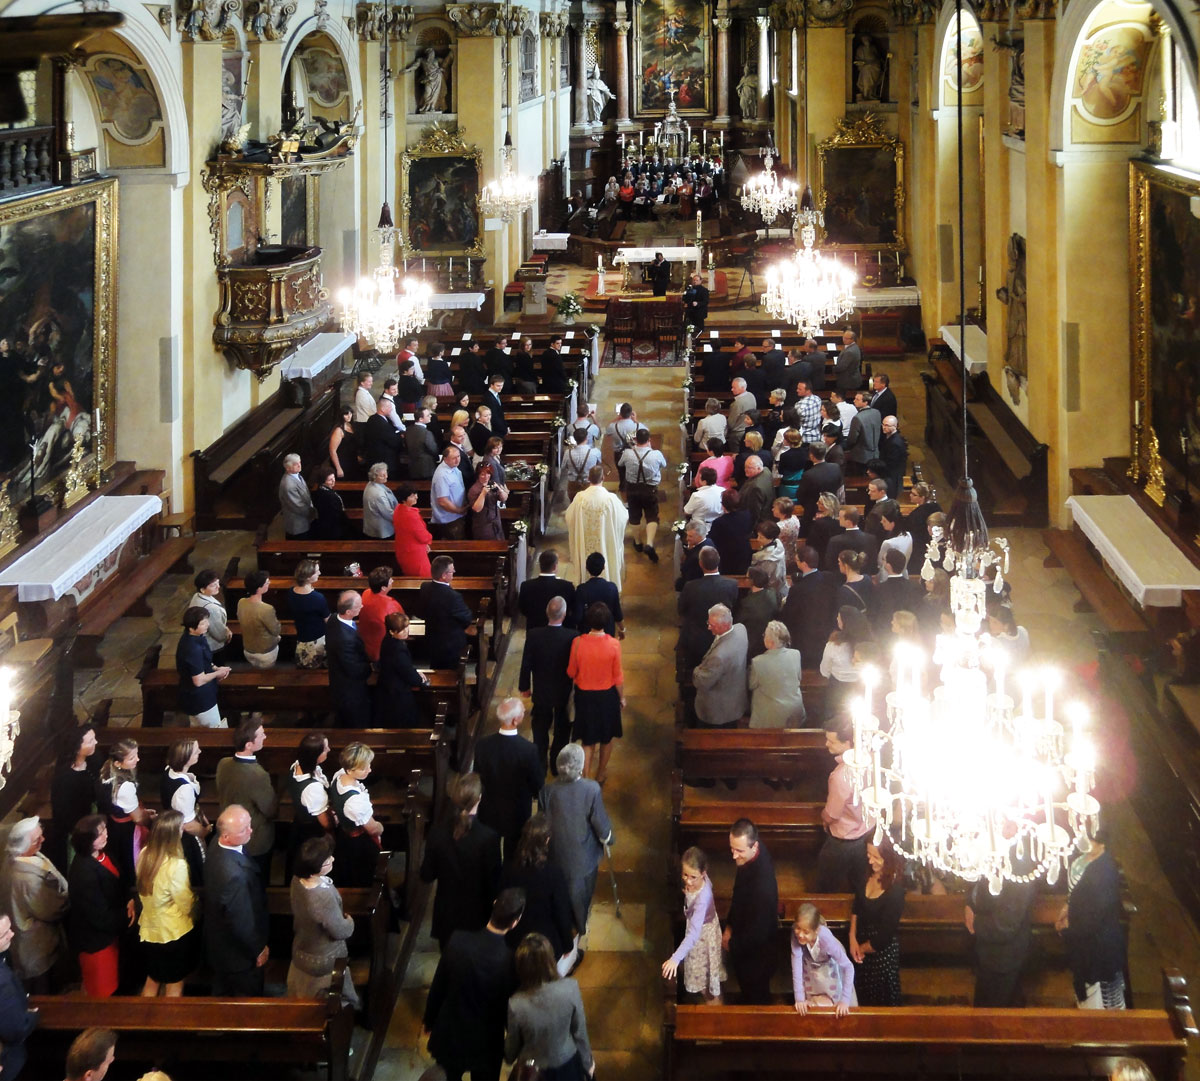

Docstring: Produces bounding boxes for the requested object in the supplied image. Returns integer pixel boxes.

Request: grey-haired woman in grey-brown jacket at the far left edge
[0,818,70,993]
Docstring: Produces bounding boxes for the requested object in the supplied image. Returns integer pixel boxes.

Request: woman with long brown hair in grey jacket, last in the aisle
[504,935,595,1081]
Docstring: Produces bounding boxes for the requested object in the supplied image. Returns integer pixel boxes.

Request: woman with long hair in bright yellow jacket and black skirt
[137,811,199,998]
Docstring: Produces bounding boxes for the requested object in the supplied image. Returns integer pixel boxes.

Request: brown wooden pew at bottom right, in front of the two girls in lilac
[662,969,1196,1081]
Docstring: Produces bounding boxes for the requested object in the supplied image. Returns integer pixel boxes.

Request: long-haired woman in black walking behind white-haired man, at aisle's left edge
[421,773,500,950]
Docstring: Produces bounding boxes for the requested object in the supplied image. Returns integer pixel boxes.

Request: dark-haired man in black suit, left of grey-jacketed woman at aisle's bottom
[422,889,524,1081]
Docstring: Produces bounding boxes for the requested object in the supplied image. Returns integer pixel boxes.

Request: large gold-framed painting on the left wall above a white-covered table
[0,180,116,503]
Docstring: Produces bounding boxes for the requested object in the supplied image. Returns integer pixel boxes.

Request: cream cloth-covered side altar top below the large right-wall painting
[1067,496,1200,608]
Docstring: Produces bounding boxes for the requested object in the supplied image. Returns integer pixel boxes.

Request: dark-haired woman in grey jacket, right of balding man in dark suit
[288,836,360,1009]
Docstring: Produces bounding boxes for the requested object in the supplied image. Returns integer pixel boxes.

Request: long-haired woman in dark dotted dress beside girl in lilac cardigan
[850,834,905,1005]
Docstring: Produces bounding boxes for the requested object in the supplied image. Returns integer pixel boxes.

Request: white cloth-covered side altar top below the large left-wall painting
[0,496,162,601]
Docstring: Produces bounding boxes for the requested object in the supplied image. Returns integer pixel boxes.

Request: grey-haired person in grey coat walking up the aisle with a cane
[538,743,612,945]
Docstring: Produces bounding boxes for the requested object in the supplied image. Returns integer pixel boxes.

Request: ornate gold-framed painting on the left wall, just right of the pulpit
[400,126,484,258]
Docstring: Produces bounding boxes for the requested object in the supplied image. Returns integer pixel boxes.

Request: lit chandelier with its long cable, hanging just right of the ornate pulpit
[337,0,433,353]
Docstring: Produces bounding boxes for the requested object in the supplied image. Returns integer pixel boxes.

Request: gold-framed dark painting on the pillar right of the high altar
[817,113,905,251]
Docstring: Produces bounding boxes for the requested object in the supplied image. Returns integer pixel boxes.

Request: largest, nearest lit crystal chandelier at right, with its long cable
[844,0,1100,895]
